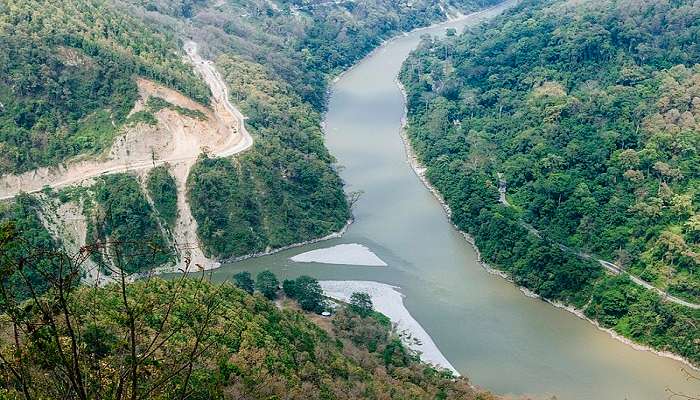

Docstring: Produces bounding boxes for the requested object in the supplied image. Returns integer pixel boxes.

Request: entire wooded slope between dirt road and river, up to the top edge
[127,0,504,259]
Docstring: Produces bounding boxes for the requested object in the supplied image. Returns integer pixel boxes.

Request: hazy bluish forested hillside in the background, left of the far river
[124,0,498,109]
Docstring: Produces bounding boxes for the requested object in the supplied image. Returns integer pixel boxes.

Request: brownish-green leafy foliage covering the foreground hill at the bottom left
[0,278,494,400]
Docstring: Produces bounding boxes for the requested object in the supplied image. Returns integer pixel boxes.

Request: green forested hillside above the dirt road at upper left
[0,0,209,175]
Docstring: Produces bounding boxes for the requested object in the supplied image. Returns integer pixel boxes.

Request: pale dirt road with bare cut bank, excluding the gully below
[0,42,253,200]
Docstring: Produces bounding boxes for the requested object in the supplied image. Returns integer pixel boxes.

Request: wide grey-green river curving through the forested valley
[208,4,700,400]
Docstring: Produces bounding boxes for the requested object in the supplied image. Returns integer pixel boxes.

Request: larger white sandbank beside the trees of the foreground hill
[320,281,459,376]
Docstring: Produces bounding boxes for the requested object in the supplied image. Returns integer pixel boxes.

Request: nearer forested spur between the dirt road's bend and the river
[189,56,350,258]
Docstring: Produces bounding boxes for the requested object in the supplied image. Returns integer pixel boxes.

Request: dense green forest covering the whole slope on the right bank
[401,0,700,363]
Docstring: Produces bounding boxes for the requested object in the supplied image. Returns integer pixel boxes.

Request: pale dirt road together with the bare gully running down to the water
[0,42,253,269]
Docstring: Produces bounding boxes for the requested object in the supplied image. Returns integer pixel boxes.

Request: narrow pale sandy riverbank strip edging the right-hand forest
[396,79,700,371]
